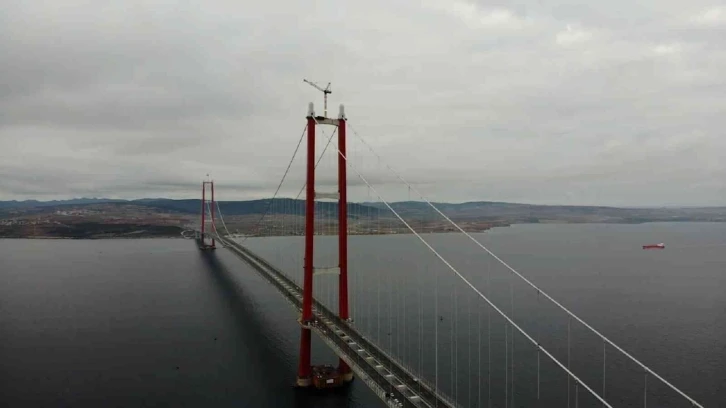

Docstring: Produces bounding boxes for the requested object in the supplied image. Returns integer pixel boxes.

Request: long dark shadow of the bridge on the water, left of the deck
[200,251,361,408]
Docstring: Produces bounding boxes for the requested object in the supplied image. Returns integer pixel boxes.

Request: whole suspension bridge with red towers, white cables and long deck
[188,99,703,407]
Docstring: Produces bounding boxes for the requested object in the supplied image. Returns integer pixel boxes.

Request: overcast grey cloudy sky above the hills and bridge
[0,0,726,205]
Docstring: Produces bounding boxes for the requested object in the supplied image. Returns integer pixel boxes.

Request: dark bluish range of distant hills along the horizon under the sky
[0,198,726,223]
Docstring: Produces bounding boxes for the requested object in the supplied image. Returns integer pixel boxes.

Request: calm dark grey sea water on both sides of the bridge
[0,223,726,407]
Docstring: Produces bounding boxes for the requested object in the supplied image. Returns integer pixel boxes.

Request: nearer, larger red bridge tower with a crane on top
[297,102,353,387]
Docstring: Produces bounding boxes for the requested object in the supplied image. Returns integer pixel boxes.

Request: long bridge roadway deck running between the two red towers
[215,235,457,407]
